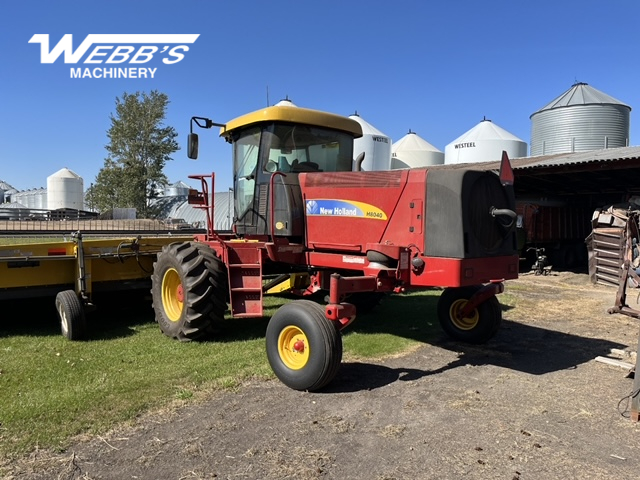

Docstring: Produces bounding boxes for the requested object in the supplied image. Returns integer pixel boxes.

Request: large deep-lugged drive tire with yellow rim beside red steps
[151,242,221,341]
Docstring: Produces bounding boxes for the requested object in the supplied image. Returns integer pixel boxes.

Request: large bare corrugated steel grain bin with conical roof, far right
[529,82,631,156]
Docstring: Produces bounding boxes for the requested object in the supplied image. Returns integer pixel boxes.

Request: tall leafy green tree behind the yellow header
[91,90,180,218]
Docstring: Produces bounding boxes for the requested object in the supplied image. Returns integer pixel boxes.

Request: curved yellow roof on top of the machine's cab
[220,105,362,138]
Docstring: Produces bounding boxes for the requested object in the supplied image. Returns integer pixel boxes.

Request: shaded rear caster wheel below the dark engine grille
[438,286,502,344]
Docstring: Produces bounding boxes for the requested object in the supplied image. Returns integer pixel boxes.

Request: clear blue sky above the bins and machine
[0,0,640,191]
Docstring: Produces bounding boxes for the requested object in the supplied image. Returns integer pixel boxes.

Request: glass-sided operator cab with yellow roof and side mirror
[189,106,362,241]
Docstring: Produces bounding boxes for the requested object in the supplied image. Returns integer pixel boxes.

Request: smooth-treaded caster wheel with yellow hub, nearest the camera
[266,300,342,391]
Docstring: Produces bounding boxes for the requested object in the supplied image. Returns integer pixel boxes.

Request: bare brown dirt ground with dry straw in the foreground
[0,273,640,480]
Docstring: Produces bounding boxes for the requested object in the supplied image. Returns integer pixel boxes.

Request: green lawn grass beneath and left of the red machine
[0,291,448,458]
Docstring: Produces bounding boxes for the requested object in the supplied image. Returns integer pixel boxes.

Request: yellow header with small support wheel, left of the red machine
[0,232,193,340]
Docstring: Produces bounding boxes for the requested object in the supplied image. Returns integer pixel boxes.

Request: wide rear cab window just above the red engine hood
[261,123,353,173]
